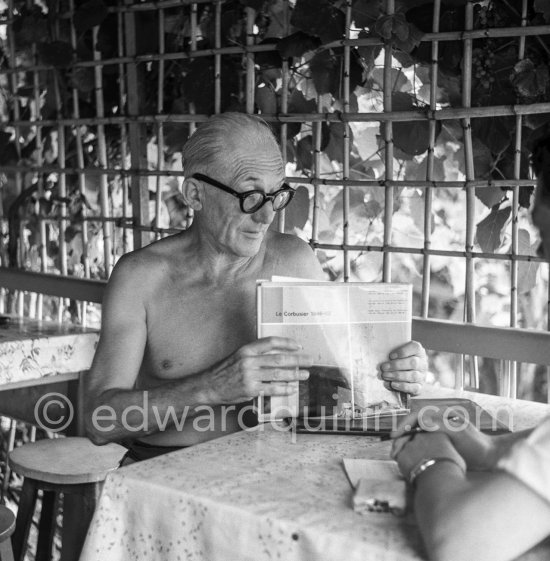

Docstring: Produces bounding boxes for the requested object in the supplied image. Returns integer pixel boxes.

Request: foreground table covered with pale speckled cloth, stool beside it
[77,392,550,561]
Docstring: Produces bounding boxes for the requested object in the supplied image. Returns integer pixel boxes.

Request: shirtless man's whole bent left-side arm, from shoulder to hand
[85,255,311,444]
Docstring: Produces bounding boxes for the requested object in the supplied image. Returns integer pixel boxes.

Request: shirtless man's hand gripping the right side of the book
[380,341,428,395]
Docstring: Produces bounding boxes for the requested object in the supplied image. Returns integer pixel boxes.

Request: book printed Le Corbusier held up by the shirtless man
[257,281,412,422]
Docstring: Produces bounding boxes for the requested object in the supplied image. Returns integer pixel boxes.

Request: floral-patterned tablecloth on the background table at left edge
[0,318,99,389]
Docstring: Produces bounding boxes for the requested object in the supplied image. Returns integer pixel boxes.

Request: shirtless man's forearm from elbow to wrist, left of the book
[85,374,218,444]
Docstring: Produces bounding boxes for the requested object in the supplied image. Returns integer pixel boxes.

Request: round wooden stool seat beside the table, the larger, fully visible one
[9,436,126,485]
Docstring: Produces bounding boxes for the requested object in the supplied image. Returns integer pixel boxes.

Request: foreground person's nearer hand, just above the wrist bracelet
[391,432,466,480]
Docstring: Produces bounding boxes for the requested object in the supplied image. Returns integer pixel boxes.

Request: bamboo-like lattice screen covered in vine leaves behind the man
[0,0,550,393]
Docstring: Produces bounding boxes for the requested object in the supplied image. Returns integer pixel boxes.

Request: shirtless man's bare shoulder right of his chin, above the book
[266,231,325,280]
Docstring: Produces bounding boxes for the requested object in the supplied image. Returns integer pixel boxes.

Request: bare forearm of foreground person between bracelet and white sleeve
[414,462,550,561]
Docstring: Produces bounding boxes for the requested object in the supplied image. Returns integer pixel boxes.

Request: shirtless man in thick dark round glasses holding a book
[85,113,427,455]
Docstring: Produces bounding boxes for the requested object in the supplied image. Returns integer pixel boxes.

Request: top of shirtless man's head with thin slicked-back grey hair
[182,113,282,180]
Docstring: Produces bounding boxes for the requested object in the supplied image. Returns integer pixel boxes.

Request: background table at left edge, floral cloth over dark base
[0,317,99,430]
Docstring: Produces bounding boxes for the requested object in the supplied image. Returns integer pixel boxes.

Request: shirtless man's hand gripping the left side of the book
[208,337,313,403]
